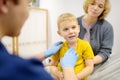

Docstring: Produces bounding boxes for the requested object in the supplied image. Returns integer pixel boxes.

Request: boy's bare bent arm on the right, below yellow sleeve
[77,59,94,80]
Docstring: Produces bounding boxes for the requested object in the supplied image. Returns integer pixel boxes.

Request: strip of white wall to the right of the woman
[107,0,120,53]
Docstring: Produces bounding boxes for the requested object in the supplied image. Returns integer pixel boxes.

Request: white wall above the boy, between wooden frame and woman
[40,0,83,44]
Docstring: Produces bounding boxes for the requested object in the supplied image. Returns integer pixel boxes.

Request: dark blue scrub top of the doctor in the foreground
[0,41,53,80]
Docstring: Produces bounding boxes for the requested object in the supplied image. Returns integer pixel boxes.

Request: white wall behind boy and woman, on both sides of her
[40,0,120,53]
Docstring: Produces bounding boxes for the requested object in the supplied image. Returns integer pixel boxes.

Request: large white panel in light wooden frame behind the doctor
[14,7,48,58]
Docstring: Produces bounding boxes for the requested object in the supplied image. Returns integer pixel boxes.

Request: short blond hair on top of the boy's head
[57,13,78,29]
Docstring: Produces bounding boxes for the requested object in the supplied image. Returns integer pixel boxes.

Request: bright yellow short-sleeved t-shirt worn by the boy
[52,38,94,80]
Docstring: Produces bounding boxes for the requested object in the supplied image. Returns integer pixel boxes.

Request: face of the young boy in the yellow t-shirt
[58,21,80,43]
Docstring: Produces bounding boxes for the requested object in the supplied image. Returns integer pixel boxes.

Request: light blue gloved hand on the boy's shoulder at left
[44,41,63,58]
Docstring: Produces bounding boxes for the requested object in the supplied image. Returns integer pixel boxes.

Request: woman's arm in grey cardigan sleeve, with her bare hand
[93,20,114,64]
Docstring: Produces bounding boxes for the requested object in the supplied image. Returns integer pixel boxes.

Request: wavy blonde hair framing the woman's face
[83,0,110,19]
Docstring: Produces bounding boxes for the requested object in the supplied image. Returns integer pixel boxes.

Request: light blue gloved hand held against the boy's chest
[60,48,78,68]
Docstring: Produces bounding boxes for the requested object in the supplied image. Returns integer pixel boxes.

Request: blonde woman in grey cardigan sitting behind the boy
[78,0,114,64]
